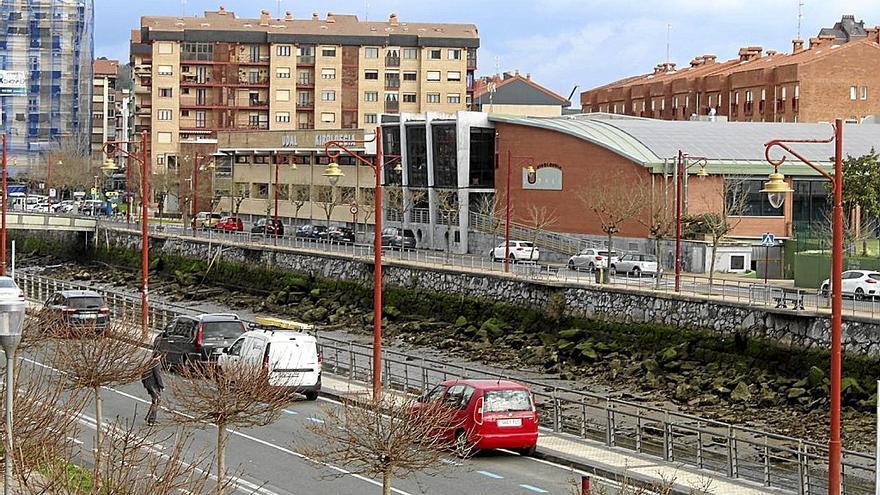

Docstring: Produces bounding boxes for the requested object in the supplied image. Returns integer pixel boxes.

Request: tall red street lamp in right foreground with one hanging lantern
[761,119,843,495]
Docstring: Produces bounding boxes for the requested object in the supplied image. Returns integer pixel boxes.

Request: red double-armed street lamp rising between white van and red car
[321,127,402,400]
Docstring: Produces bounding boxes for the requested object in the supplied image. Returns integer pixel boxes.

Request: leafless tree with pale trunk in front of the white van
[170,362,292,485]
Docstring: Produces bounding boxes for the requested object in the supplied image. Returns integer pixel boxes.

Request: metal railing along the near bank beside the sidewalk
[16,272,874,495]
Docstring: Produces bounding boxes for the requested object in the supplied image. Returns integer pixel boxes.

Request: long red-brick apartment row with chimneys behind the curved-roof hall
[581,16,880,122]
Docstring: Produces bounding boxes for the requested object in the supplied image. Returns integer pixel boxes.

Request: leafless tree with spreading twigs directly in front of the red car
[298,394,470,495]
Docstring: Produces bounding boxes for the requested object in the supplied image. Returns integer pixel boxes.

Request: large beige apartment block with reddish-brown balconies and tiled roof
[131,7,479,174]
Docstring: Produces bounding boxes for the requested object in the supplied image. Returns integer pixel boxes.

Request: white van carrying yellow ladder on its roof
[217,327,322,400]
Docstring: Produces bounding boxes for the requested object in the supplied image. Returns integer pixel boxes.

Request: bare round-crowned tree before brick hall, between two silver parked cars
[578,170,644,272]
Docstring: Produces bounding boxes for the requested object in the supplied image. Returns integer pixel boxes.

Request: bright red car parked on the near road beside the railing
[413,380,538,455]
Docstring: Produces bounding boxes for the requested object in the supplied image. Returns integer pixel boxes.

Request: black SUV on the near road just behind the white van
[153,313,246,366]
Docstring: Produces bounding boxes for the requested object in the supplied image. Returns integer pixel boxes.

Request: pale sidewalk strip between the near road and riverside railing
[321,375,788,495]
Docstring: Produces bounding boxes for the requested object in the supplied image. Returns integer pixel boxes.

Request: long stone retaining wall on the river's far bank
[99,231,880,356]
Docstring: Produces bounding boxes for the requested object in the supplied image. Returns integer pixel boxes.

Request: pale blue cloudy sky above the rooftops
[94,0,880,100]
